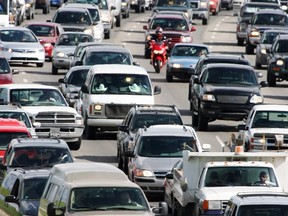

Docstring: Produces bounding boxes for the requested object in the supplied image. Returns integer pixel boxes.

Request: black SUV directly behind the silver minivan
[117,105,183,172]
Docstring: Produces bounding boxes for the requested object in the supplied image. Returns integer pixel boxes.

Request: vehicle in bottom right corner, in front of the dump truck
[224,191,288,216]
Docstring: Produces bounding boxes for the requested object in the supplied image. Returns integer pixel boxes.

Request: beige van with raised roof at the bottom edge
[38,162,168,216]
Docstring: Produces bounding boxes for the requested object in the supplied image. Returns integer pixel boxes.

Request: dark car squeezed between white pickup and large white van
[58,66,91,107]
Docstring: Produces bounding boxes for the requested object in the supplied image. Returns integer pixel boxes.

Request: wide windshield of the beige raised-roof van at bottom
[69,187,150,212]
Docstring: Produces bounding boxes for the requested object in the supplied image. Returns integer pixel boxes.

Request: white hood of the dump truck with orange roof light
[198,186,281,200]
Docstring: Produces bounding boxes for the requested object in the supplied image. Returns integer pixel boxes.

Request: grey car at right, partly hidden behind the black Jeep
[255,28,288,69]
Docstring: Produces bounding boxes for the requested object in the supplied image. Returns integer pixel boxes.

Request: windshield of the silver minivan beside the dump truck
[138,136,198,158]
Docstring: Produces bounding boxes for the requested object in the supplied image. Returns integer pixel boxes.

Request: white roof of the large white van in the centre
[88,64,149,76]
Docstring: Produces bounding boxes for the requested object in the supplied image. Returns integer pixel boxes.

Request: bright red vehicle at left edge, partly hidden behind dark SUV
[0,118,31,162]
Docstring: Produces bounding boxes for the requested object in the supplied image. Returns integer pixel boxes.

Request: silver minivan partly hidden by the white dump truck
[125,125,208,195]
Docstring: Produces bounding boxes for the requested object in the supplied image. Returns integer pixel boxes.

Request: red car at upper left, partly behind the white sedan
[26,22,64,61]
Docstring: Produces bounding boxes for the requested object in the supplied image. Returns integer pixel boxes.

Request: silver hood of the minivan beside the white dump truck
[136,156,180,172]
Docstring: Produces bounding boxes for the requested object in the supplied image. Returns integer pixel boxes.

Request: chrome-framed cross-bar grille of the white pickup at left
[35,112,76,125]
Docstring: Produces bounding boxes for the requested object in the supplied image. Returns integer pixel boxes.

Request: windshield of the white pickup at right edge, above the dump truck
[252,111,288,128]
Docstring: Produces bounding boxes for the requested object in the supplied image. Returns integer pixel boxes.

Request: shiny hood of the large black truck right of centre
[203,84,260,95]
